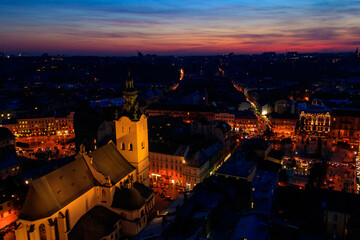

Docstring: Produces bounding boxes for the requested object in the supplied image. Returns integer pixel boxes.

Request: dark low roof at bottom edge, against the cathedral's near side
[68,206,120,240]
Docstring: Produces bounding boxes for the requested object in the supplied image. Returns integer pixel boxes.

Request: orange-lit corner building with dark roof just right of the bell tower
[150,141,228,189]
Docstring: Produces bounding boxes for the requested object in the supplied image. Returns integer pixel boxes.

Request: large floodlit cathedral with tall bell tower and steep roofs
[15,76,155,240]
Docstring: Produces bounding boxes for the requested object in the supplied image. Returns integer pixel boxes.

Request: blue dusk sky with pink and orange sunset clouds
[0,0,360,55]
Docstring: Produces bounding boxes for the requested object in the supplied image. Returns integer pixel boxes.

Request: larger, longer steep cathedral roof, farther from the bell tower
[19,156,96,221]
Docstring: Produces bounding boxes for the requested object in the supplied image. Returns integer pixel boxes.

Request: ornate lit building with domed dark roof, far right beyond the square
[299,99,331,135]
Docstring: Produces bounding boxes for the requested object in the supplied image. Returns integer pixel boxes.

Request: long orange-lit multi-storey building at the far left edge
[2,112,75,137]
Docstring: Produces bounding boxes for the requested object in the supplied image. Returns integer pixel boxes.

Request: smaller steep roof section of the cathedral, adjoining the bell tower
[91,141,136,183]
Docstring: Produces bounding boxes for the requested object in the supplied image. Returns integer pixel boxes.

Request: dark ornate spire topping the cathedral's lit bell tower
[123,72,141,121]
